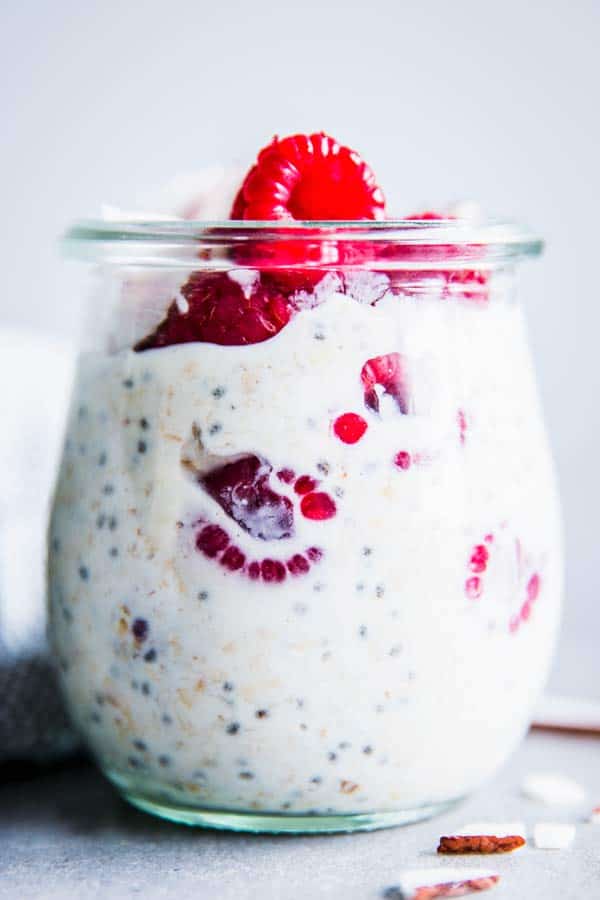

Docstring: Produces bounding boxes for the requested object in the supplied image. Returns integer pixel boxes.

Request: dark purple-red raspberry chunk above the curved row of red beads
[200,456,294,541]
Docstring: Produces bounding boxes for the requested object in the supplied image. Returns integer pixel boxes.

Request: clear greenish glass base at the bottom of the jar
[122,791,462,834]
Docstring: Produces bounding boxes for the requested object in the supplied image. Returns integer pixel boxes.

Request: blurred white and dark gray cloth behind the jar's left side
[0,329,75,761]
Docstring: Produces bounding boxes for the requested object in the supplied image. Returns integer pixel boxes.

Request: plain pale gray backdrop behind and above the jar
[0,0,600,693]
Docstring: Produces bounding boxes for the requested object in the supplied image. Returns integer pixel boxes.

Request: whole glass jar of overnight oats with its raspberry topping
[49,135,562,831]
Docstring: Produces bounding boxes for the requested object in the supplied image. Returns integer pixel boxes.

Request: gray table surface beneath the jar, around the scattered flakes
[0,733,600,900]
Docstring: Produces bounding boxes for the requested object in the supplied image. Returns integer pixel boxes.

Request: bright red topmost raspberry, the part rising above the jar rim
[231,132,385,221]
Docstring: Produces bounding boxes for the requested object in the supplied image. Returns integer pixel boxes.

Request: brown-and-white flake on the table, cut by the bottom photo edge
[383,867,500,900]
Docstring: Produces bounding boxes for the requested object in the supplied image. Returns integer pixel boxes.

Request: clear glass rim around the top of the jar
[62,218,543,265]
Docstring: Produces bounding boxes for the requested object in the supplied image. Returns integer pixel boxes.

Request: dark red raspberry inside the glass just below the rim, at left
[134,272,291,352]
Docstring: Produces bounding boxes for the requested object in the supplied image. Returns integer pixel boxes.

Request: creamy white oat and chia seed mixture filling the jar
[50,276,561,813]
